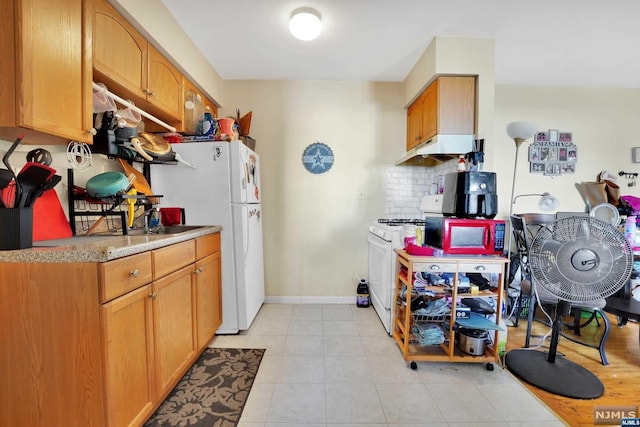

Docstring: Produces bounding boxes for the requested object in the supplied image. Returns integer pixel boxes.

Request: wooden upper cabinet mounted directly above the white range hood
[407,76,476,151]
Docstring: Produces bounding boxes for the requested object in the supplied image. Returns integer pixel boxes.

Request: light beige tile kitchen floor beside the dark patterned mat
[211,304,564,427]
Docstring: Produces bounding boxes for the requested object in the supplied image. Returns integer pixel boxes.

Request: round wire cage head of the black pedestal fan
[529,216,633,304]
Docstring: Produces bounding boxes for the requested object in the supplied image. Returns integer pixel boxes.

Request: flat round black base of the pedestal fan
[505,349,604,399]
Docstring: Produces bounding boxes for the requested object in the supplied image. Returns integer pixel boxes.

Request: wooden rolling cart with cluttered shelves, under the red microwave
[393,249,508,370]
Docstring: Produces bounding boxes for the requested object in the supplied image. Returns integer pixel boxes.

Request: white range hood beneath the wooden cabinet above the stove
[396,135,474,166]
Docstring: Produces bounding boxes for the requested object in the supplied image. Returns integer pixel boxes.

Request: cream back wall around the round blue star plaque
[221,81,406,301]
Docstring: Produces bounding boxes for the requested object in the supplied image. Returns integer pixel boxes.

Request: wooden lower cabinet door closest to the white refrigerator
[195,252,222,349]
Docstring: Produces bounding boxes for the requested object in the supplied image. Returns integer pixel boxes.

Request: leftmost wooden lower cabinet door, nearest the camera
[102,285,156,427]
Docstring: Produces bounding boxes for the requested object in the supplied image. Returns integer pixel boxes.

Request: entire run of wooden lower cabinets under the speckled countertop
[0,233,222,427]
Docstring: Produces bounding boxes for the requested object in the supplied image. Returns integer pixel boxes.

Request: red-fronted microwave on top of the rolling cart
[424,217,506,255]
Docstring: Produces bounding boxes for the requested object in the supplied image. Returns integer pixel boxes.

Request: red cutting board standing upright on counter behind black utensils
[33,190,72,242]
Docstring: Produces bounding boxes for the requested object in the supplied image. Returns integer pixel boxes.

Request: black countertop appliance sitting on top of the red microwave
[442,172,498,219]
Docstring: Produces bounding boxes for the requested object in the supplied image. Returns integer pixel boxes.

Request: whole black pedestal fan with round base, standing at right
[505,216,633,399]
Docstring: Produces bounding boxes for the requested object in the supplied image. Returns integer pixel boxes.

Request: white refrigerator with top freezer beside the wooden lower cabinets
[150,141,264,334]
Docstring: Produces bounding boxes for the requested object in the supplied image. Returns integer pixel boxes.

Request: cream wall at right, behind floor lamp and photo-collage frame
[492,85,640,217]
